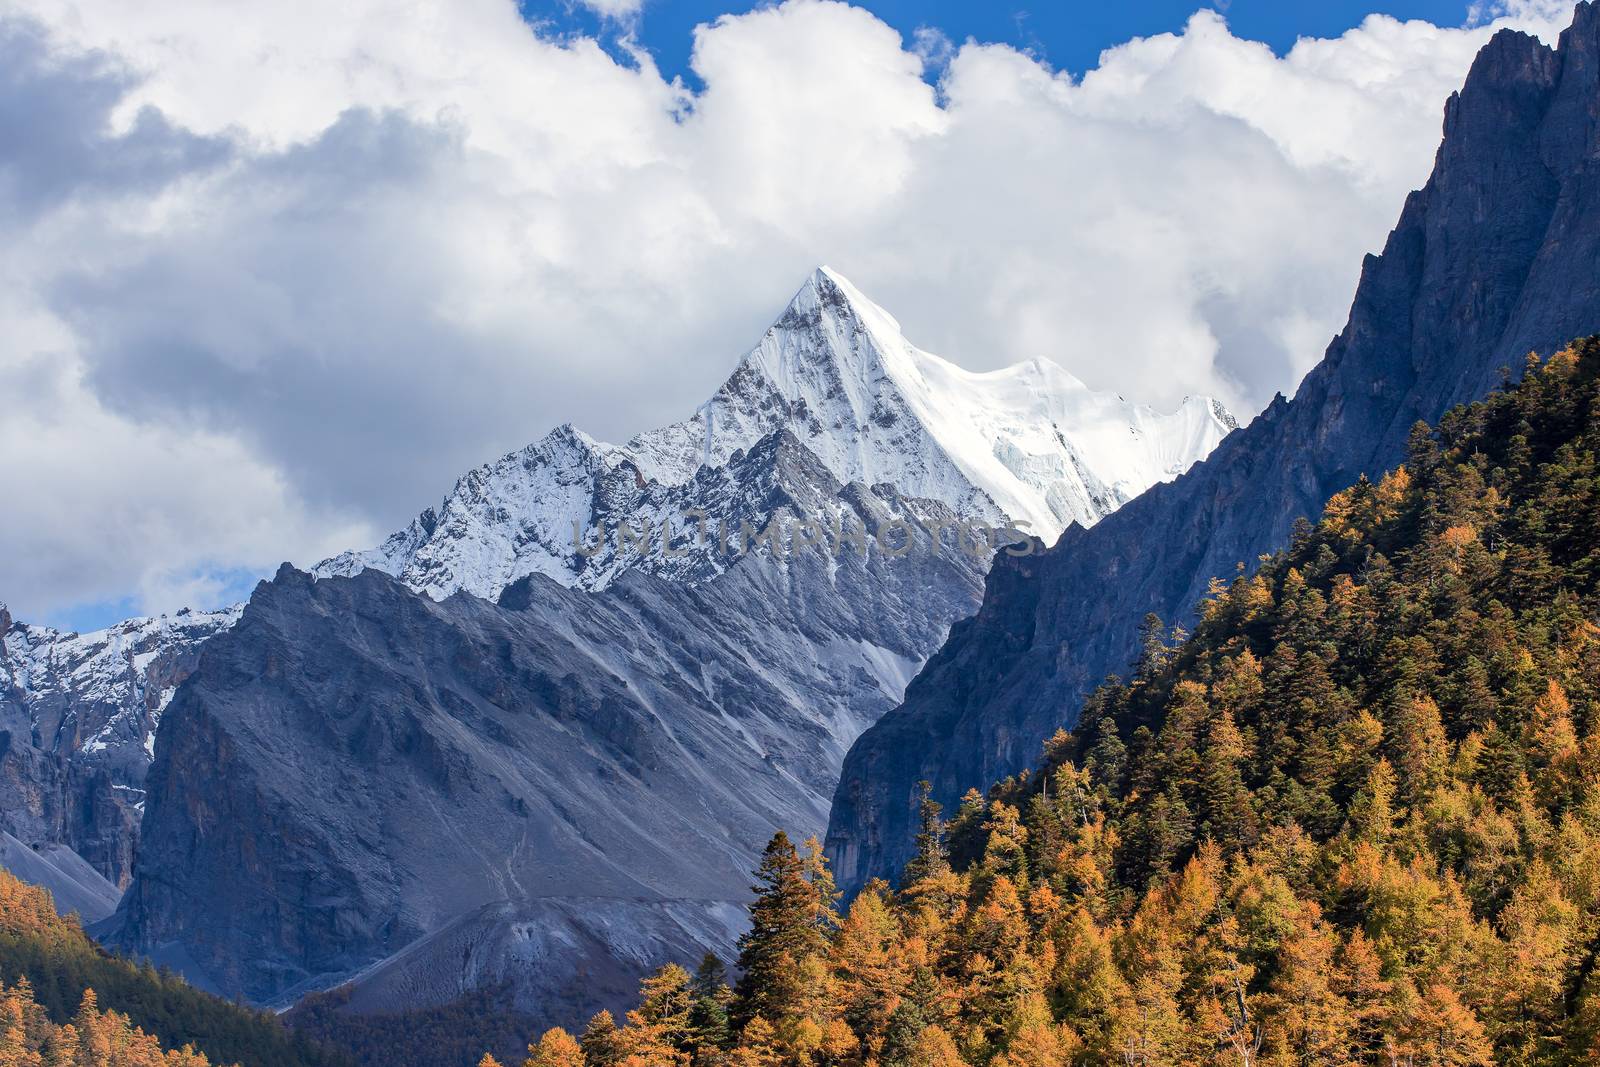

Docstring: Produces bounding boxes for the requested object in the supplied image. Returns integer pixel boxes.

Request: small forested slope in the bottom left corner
[0,869,354,1067]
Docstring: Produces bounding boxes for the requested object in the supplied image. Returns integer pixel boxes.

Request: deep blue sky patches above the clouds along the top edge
[522,0,1467,88]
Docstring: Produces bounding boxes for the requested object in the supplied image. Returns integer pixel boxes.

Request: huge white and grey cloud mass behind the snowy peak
[0,0,1565,617]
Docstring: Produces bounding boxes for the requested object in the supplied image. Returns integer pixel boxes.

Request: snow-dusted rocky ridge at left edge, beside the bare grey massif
[0,605,240,883]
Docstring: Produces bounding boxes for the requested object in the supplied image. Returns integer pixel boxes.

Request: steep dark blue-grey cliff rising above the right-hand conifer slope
[829,3,1600,888]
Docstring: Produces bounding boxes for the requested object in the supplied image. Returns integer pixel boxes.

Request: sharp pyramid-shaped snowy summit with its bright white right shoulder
[656,267,1235,539]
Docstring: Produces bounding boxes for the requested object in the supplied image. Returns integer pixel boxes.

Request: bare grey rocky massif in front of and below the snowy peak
[104,432,986,1021]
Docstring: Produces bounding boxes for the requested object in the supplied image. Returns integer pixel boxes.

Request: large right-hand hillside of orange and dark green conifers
[533,338,1600,1067]
